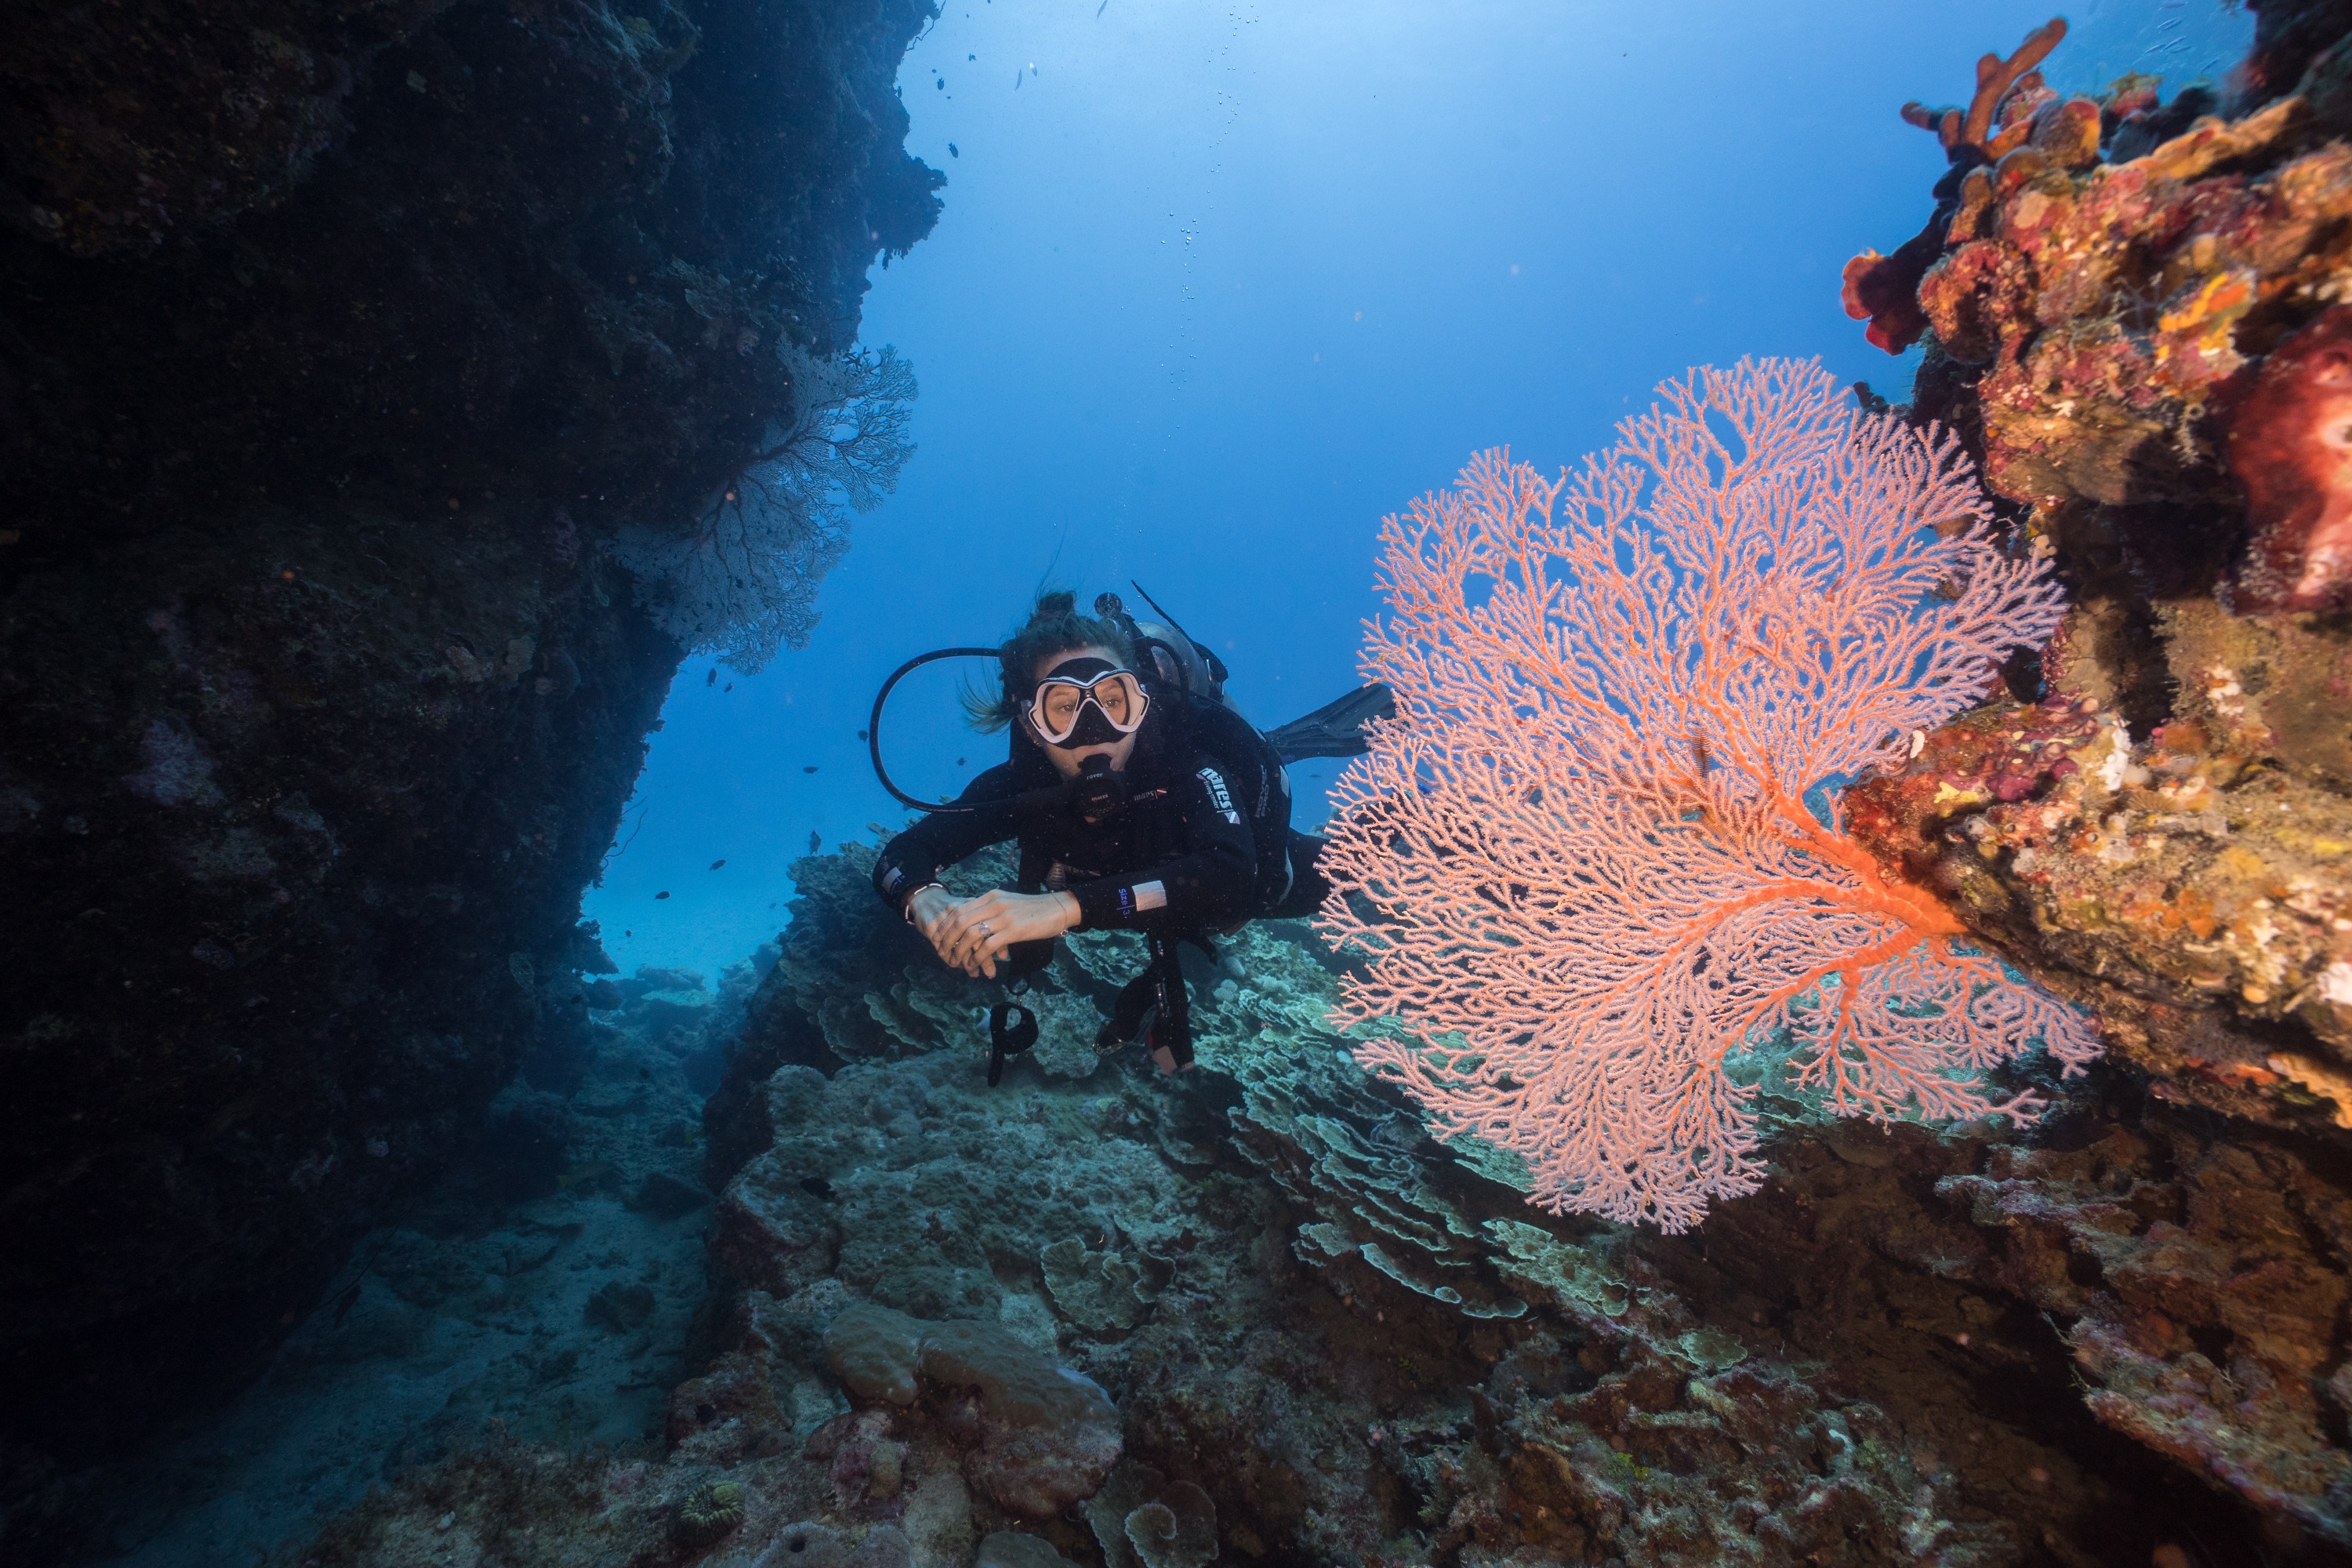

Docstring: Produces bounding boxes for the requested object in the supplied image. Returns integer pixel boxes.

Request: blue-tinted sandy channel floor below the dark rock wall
[75,964,724,1568]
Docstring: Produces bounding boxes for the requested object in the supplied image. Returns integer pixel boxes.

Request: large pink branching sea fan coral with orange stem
[1322,360,2098,1232]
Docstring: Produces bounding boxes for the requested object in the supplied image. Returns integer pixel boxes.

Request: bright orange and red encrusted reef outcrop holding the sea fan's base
[1846,5,2352,1140]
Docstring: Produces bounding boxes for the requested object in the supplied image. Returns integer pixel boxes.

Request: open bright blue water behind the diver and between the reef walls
[586,0,2251,975]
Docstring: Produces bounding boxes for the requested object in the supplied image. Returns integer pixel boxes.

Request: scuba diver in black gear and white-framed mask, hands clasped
[868,588,1395,1083]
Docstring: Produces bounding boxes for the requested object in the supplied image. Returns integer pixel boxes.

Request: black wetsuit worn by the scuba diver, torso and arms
[875,696,1322,973]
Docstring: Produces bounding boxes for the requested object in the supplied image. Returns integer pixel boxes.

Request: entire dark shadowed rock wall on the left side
[0,0,941,1495]
